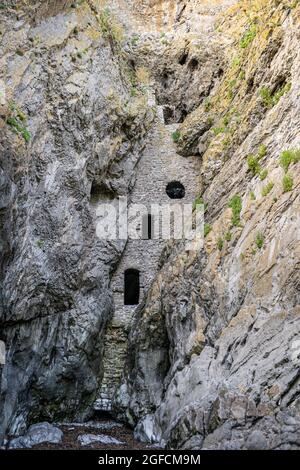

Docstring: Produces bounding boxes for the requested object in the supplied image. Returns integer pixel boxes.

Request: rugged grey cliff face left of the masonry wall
[0,2,153,440]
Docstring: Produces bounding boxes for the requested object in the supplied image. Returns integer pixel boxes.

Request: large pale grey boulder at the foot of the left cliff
[8,423,63,449]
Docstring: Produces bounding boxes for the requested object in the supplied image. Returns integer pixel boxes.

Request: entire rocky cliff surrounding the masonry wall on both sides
[0,0,300,449]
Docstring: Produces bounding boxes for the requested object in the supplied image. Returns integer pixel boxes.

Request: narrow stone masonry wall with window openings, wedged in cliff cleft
[95,97,199,410]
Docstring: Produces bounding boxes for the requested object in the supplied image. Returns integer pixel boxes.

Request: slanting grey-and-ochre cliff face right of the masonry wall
[112,1,300,449]
